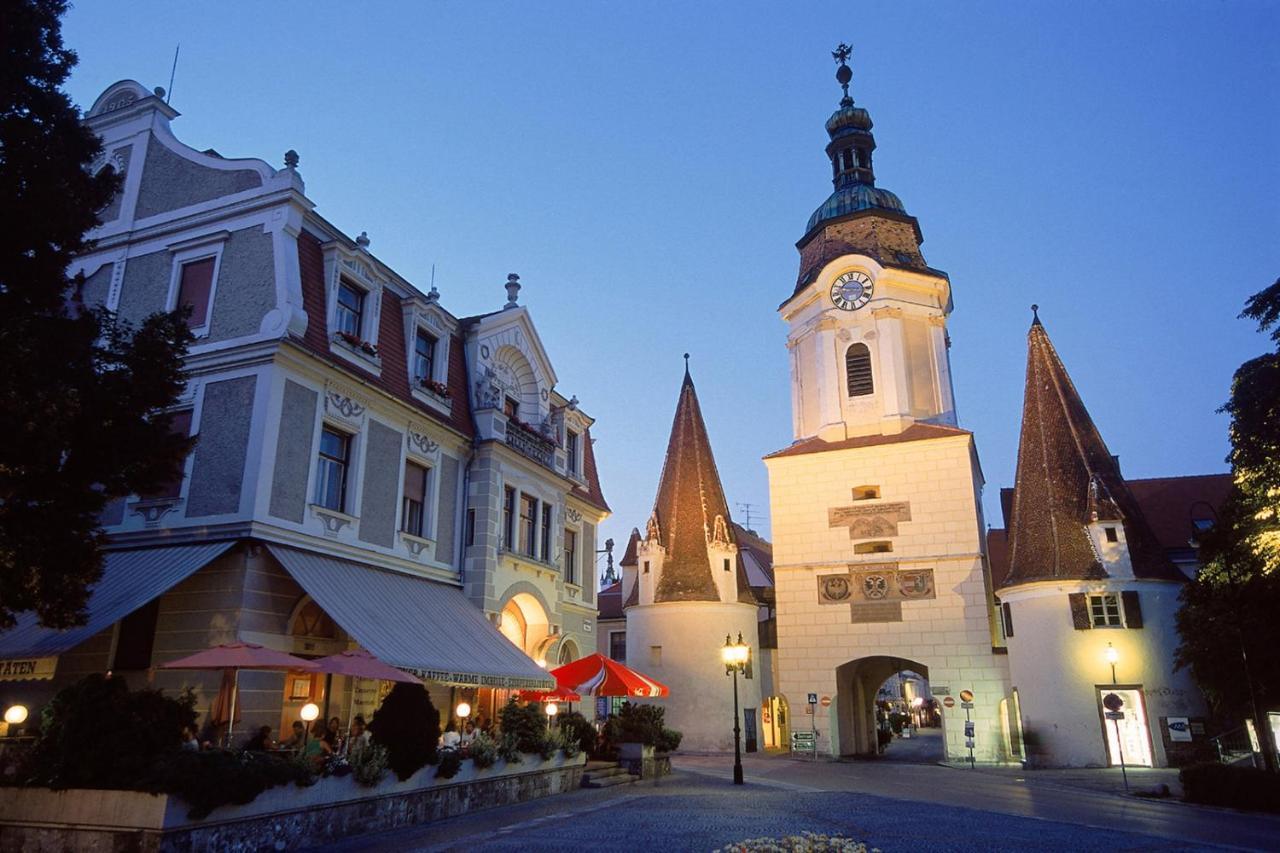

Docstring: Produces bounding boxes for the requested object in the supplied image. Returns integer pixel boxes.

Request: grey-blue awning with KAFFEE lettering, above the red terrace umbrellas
[268,544,556,689]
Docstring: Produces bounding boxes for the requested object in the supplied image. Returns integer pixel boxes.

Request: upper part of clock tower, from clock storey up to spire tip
[778,46,956,442]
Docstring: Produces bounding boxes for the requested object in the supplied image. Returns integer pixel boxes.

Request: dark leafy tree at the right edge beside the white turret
[1176,279,1280,766]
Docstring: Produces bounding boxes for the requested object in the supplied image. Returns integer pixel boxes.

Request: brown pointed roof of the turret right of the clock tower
[1002,315,1183,587]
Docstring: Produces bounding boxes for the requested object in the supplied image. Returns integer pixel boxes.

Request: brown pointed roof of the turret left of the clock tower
[653,364,744,603]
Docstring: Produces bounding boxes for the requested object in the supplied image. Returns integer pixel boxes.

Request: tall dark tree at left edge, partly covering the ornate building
[0,0,192,630]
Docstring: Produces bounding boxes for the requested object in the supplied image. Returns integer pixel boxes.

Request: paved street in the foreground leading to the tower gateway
[307,756,1280,853]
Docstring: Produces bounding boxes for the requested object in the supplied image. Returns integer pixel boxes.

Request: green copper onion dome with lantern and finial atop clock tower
[805,45,906,233]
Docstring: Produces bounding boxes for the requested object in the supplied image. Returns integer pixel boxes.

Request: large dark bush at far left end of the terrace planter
[27,675,196,790]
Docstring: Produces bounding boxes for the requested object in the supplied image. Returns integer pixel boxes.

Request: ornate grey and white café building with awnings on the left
[0,81,608,731]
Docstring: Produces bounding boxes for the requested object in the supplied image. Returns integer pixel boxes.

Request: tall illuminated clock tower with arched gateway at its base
[765,45,1011,762]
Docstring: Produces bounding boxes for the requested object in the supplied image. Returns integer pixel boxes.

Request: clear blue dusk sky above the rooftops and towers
[64,0,1280,581]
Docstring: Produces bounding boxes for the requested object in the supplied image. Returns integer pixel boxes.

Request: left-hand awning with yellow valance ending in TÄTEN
[0,542,236,681]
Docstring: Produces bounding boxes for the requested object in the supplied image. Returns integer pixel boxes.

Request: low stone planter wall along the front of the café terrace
[0,752,586,853]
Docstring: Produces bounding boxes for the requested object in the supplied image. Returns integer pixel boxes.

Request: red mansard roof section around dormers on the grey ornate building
[298,232,475,438]
